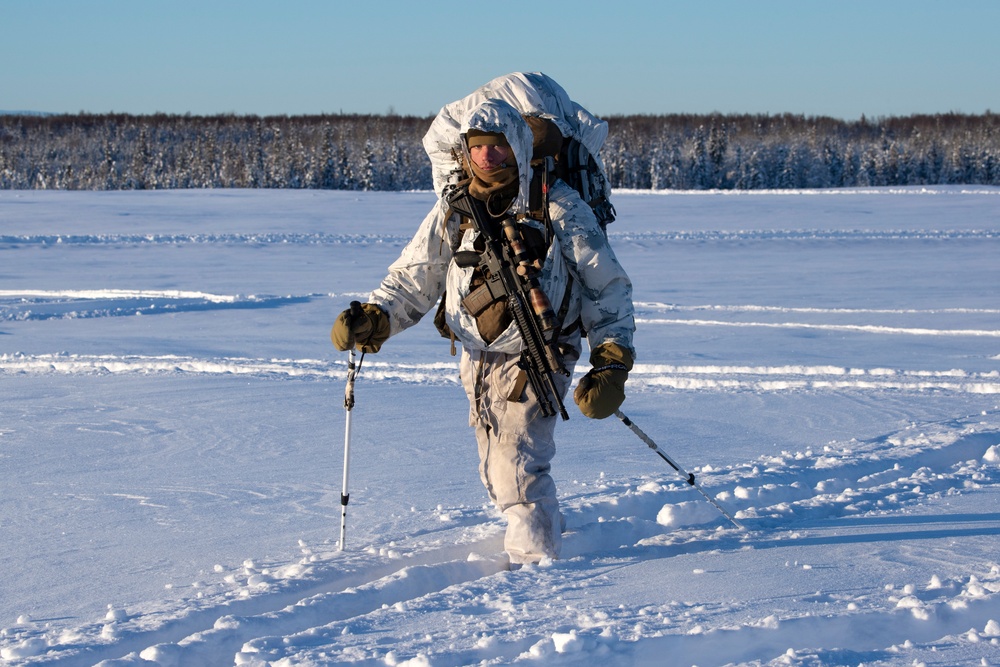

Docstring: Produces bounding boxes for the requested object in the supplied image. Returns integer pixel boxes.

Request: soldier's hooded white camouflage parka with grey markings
[369,99,635,366]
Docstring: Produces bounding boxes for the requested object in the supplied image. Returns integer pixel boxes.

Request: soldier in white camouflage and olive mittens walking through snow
[331,99,635,568]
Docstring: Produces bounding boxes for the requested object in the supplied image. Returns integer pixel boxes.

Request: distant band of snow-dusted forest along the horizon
[0,112,1000,190]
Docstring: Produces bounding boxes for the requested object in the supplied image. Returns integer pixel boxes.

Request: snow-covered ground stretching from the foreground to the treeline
[0,187,1000,667]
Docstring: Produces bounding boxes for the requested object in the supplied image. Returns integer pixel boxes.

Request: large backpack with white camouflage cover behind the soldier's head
[423,72,615,228]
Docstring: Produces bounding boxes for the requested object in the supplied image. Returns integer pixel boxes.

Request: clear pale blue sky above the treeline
[0,0,1000,119]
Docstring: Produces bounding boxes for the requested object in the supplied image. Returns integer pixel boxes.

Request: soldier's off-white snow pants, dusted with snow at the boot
[460,334,580,563]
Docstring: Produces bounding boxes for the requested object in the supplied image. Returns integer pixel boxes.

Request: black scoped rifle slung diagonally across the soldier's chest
[444,185,569,419]
